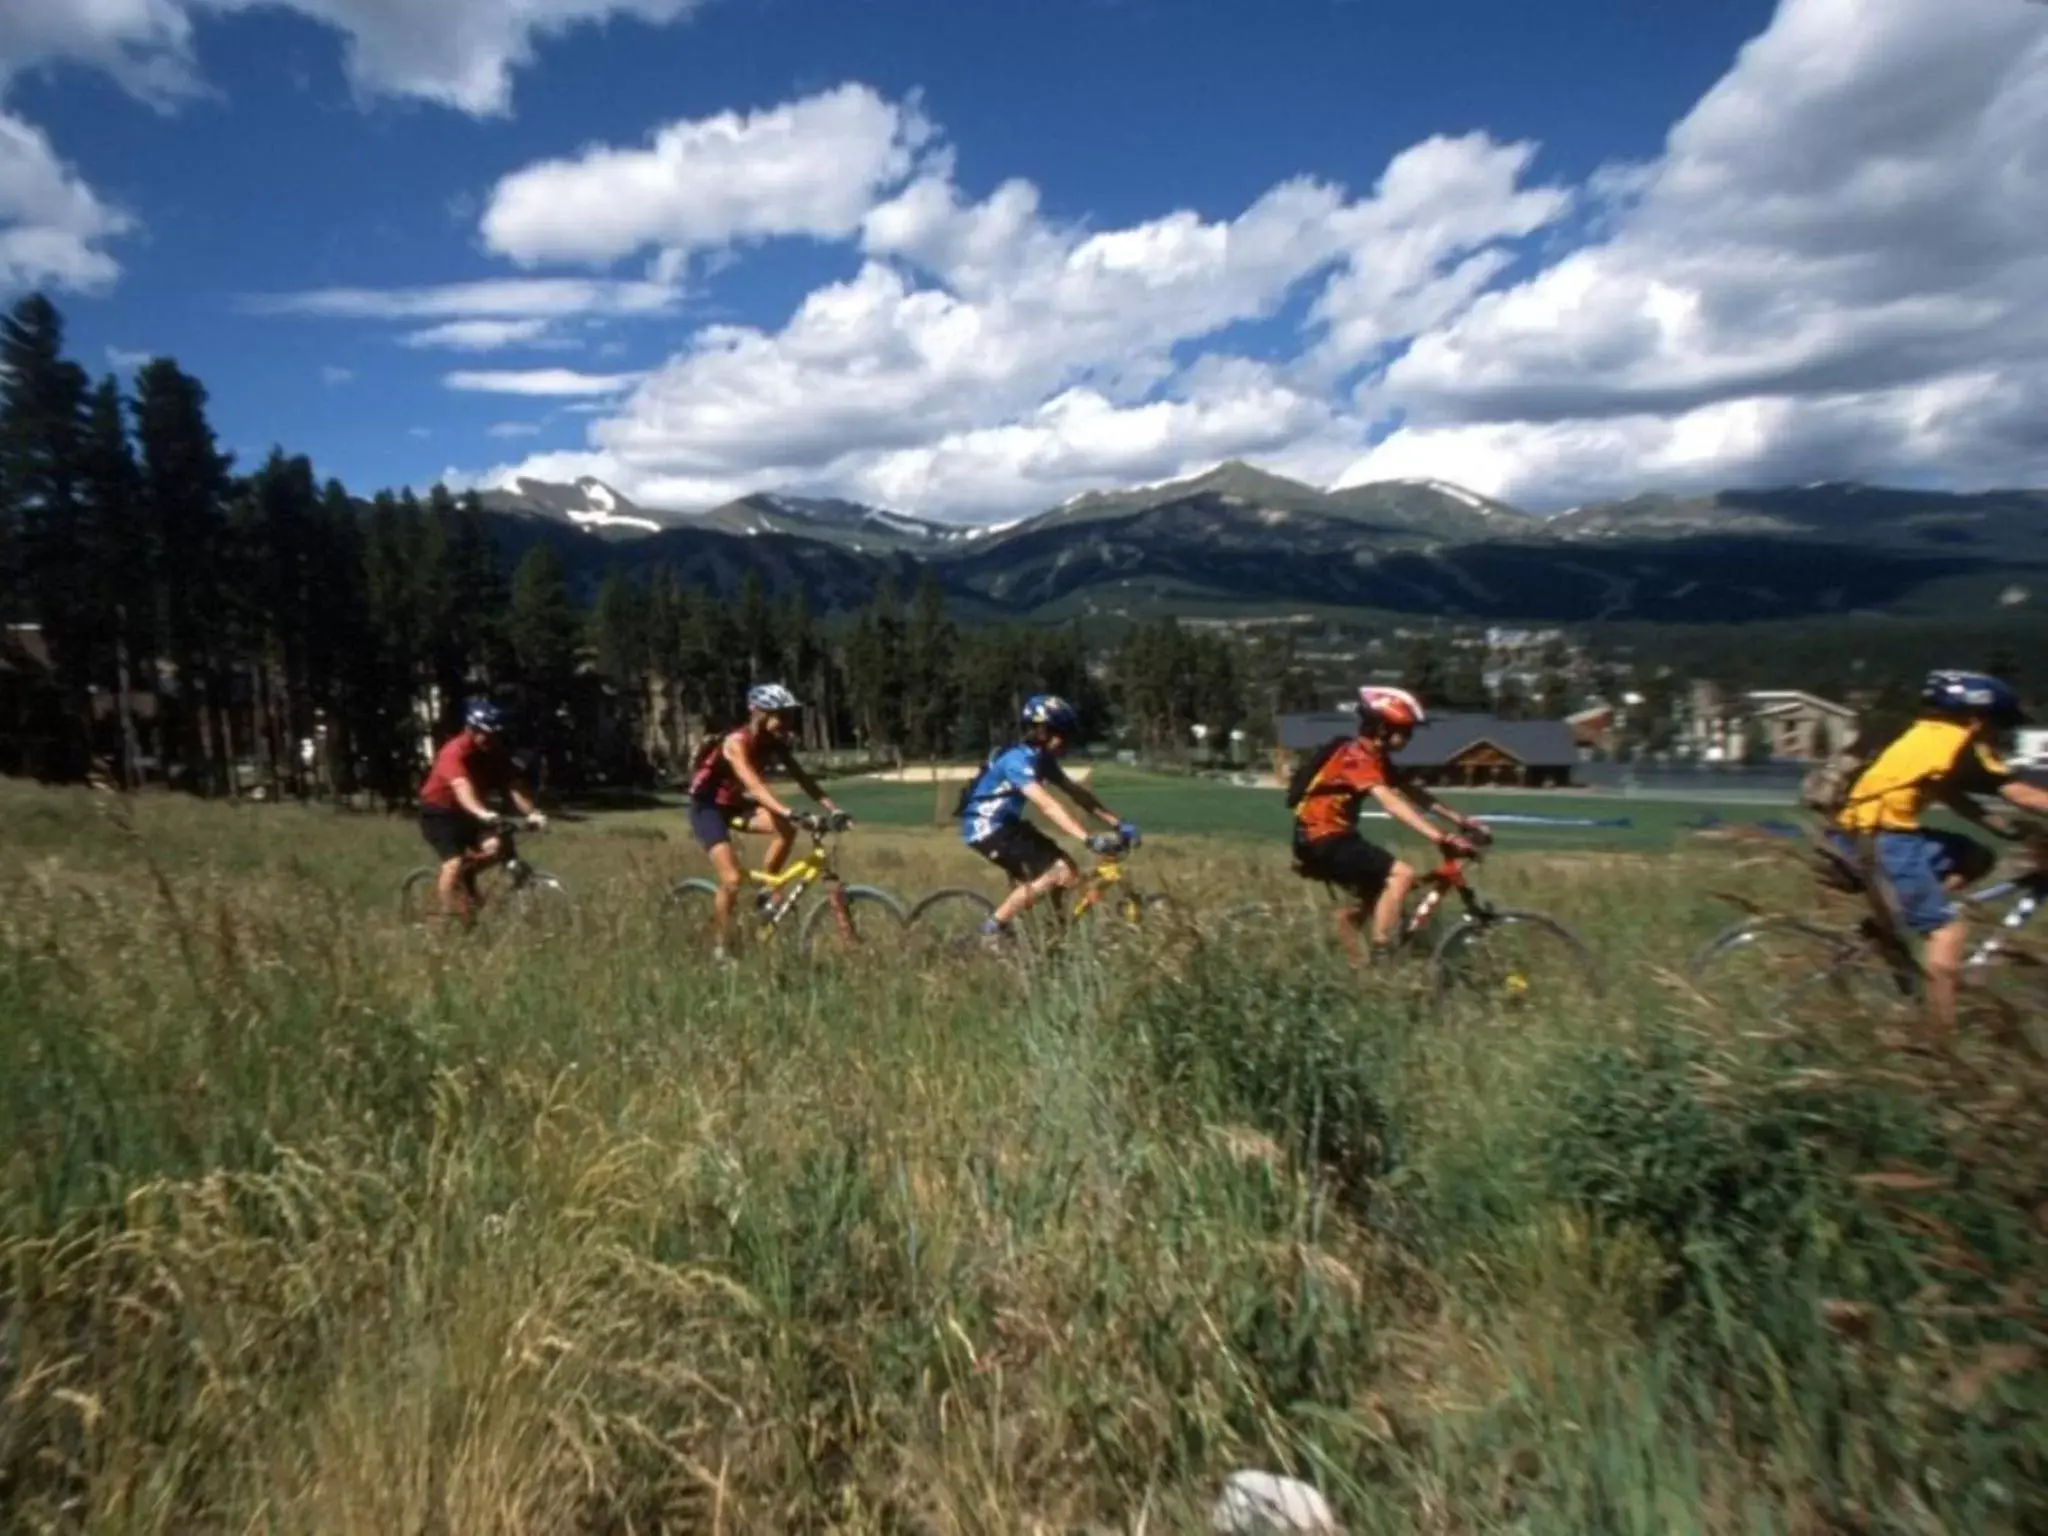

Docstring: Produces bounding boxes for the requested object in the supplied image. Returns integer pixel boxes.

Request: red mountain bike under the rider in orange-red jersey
[1208,834,1606,1008]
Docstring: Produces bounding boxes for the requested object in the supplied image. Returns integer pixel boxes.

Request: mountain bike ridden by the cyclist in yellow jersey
[1686,829,2048,1055]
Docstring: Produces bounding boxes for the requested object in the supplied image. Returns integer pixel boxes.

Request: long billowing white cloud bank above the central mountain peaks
[487,121,1569,514]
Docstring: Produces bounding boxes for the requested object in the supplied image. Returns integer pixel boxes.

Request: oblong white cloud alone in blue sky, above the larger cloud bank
[483,86,930,264]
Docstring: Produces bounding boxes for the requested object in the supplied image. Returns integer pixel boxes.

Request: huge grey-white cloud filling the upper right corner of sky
[1346,0,2048,502]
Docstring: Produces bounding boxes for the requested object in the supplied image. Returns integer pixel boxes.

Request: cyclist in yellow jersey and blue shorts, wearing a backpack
[1829,672,2048,1034]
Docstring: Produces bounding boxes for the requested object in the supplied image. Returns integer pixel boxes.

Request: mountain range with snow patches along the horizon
[471,461,2048,623]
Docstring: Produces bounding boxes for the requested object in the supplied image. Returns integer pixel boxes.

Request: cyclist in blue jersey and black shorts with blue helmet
[961,694,1139,938]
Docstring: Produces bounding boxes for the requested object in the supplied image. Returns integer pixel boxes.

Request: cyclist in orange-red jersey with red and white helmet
[1294,684,1485,965]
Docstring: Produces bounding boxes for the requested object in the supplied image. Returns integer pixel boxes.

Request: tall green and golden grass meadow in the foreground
[0,786,2048,1536]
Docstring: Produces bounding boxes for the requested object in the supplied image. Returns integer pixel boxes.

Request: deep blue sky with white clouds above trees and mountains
[0,0,2048,518]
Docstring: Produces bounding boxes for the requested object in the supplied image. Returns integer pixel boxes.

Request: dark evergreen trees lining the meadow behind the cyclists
[0,288,1744,805]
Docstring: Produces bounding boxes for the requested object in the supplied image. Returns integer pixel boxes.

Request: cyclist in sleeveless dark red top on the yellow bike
[690,682,850,961]
